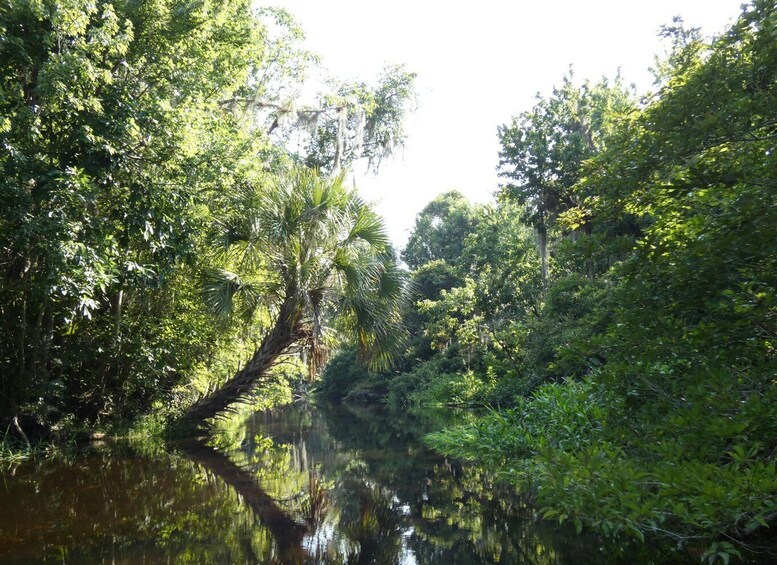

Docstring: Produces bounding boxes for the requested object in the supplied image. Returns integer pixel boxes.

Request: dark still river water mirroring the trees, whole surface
[0,405,668,564]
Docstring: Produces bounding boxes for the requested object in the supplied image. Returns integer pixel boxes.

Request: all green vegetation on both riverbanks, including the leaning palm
[0,0,777,563]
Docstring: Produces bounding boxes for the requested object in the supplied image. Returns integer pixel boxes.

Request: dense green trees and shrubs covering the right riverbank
[320,0,777,561]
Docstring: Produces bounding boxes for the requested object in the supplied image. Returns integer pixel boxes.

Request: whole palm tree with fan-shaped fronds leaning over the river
[186,168,407,425]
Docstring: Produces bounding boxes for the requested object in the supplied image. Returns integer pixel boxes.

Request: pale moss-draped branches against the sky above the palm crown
[221,26,416,175]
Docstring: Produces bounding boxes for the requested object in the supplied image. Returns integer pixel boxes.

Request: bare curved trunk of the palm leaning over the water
[185,299,307,427]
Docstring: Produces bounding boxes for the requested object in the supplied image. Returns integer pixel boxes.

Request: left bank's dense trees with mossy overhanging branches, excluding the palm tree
[0,0,414,439]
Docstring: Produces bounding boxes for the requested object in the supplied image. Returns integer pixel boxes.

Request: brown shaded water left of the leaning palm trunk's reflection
[0,450,275,563]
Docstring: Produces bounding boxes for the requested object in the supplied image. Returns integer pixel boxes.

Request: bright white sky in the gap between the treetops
[270,0,742,248]
